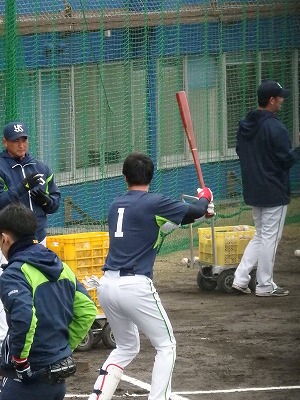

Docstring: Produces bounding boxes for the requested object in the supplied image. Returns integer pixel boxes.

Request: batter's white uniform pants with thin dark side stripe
[98,271,176,400]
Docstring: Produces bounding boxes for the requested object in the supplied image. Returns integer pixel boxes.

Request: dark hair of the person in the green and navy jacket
[0,203,37,240]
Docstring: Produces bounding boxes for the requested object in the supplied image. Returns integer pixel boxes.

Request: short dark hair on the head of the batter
[122,153,154,186]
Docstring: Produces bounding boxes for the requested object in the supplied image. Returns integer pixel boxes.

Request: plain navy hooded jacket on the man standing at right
[236,110,300,207]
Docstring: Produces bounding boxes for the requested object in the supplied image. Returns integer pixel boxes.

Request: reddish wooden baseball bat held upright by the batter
[176,90,205,188]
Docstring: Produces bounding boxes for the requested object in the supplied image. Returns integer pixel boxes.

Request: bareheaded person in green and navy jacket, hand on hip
[0,203,97,400]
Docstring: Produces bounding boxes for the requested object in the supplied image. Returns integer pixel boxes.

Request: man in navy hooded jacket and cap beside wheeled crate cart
[232,80,300,297]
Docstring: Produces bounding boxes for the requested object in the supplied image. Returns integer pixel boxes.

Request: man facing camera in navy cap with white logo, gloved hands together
[0,121,60,242]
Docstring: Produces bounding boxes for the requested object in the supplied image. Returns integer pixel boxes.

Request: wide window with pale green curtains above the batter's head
[34,62,146,184]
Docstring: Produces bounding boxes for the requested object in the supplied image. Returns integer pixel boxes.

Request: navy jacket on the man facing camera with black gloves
[0,150,60,242]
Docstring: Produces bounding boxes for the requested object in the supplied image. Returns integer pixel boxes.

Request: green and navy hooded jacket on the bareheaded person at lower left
[0,237,97,370]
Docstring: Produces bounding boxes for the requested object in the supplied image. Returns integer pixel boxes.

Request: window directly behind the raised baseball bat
[157,56,219,168]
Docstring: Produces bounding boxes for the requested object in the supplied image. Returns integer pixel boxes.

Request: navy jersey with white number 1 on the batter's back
[103,190,208,278]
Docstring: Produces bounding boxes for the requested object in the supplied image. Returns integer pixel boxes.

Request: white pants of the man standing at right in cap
[234,206,287,293]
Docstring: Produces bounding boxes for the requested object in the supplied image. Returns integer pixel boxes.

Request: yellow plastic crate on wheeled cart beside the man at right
[198,225,255,266]
